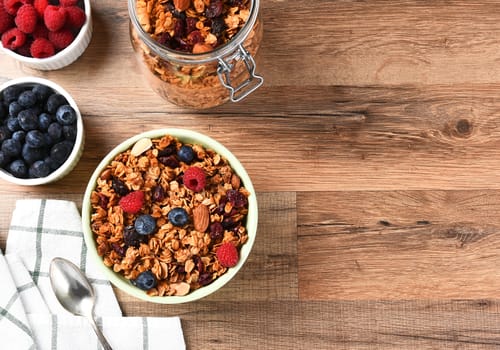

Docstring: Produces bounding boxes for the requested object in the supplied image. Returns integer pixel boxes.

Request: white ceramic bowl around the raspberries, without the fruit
[0,0,93,70]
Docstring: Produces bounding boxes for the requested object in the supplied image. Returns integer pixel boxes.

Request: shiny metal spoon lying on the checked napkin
[49,258,112,350]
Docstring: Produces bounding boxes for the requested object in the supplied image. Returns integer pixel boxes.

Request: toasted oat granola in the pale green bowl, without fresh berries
[90,135,250,296]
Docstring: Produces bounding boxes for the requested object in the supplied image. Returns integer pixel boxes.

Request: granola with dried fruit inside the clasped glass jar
[130,0,263,108]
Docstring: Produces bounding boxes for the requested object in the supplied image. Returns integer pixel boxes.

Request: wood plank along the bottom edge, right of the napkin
[118,300,500,350]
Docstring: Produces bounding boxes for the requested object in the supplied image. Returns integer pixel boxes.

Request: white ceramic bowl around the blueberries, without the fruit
[0,77,85,186]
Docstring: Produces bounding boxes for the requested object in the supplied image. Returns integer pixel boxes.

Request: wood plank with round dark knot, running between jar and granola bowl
[0,85,500,192]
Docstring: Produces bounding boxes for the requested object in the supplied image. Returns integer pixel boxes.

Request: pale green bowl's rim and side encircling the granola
[82,129,258,304]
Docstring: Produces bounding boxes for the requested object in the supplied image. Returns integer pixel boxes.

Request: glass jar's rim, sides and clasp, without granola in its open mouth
[128,0,264,109]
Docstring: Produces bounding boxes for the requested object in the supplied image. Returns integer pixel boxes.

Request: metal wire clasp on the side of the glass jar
[217,45,264,102]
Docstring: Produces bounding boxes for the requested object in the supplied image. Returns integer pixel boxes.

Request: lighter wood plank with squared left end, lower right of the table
[297,191,500,300]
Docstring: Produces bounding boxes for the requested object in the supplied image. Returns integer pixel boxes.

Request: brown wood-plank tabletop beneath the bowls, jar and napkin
[0,0,500,349]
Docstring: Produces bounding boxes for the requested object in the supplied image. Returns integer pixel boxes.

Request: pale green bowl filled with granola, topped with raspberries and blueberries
[82,129,258,304]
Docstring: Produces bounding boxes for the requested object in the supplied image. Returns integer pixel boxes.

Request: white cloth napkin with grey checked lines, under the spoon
[0,199,186,350]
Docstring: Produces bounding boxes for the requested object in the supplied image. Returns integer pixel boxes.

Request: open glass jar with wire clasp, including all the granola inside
[128,0,263,109]
